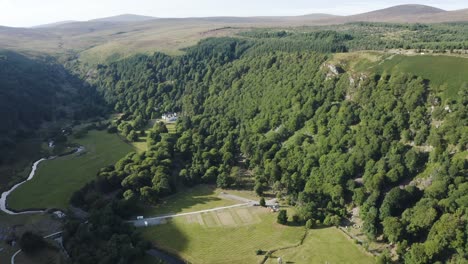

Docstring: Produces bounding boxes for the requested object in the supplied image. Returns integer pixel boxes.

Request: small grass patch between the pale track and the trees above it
[135,185,239,216]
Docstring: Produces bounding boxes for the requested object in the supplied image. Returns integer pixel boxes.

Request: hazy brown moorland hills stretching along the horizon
[0,5,468,64]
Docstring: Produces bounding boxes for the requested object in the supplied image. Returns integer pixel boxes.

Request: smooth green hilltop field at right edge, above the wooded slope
[377,55,468,100]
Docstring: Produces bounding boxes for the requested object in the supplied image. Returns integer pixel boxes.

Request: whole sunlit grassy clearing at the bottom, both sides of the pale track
[140,185,373,263]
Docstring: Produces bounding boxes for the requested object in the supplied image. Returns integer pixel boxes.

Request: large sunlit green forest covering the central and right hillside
[64,25,468,263]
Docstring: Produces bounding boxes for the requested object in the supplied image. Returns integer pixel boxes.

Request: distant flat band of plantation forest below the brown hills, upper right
[239,22,468,54]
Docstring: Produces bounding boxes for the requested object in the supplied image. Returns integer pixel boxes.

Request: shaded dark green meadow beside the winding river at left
[8,131,133,210]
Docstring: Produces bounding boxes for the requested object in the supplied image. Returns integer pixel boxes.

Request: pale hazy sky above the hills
[0,0,468,27]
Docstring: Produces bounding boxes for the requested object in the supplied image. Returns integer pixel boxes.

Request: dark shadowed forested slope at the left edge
[0,51,105,164]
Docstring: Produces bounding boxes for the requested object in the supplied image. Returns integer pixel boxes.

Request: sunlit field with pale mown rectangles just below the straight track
[142,207,304,263]
